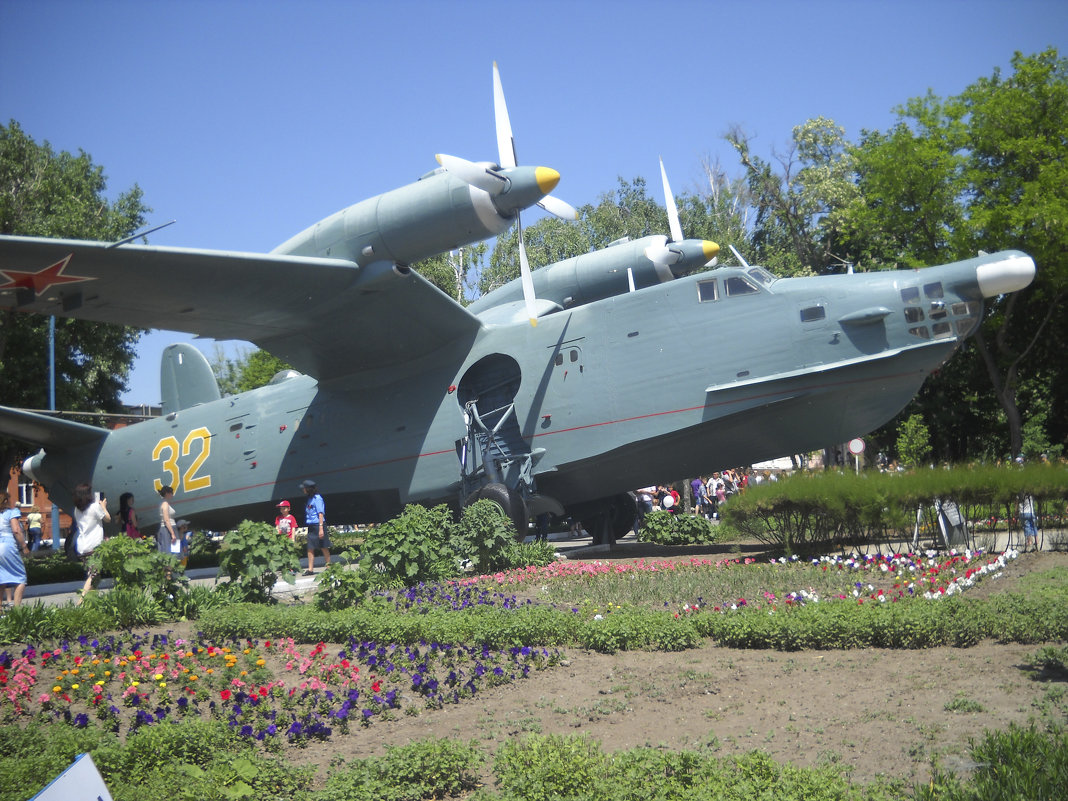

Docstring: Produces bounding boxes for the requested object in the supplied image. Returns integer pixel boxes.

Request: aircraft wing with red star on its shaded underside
[0,236,482,380]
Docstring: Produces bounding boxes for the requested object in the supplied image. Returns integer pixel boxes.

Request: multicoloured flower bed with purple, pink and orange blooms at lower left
[0,634,560,742]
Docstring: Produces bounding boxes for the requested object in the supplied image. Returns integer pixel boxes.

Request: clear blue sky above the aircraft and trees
[0,0,1068,404]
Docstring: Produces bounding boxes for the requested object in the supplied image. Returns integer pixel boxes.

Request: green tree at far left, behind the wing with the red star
[0,120,151,466]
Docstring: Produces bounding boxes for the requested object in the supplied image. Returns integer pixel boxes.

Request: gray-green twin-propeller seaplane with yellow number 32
[0,64,1035,543]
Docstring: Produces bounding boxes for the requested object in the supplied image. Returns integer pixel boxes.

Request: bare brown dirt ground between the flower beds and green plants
[269,547,1068,783]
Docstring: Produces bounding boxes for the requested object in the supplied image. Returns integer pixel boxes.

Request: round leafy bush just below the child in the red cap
[219,520,300,603]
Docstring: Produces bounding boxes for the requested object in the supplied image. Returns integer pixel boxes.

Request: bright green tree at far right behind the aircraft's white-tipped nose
[831,48,1068,455]
